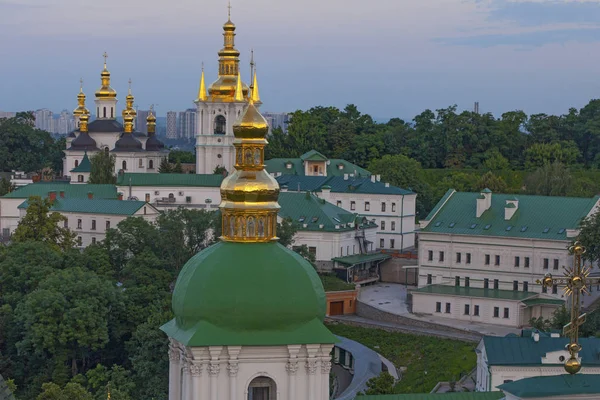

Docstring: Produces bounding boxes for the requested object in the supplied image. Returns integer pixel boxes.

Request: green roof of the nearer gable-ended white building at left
[19,198,152,215]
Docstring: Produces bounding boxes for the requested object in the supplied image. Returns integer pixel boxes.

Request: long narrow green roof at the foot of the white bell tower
[117,173,224,187]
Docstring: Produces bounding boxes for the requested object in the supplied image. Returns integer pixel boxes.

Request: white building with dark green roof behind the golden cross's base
[475,331,600,392]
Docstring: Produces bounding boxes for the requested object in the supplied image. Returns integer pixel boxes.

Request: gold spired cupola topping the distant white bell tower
[208,6,248,101]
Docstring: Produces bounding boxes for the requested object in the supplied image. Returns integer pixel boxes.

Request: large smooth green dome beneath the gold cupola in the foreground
[161,242,336,346]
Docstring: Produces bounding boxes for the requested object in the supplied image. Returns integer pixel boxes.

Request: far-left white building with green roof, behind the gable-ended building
[0,182,117,238]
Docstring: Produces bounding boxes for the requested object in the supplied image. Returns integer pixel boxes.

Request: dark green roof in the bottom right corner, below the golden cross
[498,374,600,399]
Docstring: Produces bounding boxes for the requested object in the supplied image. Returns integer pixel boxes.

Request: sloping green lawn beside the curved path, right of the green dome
[327,324,477,393]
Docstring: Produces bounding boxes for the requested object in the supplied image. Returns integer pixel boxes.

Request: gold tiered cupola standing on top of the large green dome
[219,98,279,242]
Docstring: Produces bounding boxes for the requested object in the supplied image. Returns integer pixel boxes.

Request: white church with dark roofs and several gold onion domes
[63,54,168,183]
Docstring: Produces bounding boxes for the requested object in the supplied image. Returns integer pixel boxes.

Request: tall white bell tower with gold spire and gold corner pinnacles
[195,9,261,174]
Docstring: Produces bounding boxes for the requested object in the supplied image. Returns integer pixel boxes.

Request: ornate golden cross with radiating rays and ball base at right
[537,242,600,374]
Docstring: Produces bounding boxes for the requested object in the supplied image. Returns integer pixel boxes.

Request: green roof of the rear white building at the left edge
[3,182,117,199]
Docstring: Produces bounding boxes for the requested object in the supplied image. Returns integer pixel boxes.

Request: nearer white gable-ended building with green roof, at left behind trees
[19,192,158,248]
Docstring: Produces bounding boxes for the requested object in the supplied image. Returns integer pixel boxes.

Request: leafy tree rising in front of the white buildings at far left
[12,196,75,251]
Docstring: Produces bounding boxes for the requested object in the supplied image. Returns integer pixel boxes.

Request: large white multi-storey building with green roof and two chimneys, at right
[413,189,599,327]
